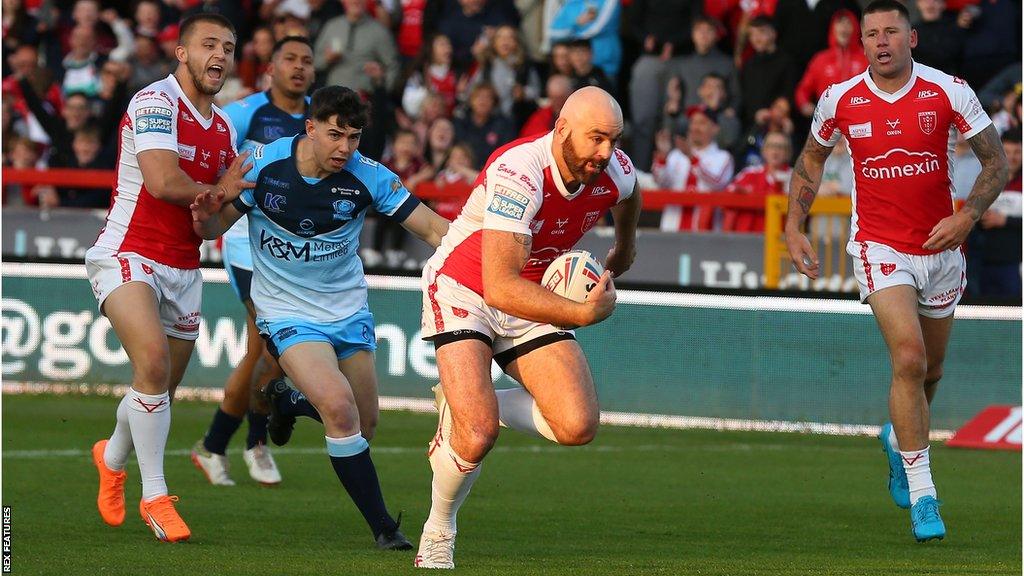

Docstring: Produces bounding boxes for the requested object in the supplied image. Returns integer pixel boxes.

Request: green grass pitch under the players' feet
[2,395,1021,576]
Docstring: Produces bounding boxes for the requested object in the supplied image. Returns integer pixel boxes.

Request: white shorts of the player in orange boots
[85,246,203,340]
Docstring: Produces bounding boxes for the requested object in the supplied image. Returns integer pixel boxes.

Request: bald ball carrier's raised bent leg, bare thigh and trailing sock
[498,340,600,446]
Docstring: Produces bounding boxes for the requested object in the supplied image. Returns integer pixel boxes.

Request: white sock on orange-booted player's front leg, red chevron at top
[128,388,171,500]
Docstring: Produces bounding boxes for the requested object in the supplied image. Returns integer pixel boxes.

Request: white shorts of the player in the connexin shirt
[846,241,967,318]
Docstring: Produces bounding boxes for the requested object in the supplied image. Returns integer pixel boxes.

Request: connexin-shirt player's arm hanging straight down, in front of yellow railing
[785,134,831,279]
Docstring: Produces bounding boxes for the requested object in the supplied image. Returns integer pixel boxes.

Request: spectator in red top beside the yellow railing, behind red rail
[722,132,793,233]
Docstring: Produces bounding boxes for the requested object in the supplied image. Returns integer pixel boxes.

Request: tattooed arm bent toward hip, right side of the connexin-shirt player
[922,125,1010,251]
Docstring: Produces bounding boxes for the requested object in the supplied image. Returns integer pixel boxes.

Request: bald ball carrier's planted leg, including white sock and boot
[415,339,499,568]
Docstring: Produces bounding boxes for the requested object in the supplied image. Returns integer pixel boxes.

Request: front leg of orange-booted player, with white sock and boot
[100,282,194,541]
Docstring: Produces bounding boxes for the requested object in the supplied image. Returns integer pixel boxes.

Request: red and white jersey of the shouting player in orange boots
[95,75,236,269]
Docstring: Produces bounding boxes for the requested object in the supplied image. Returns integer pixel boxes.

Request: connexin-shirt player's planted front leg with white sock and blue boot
[867,285,951,541]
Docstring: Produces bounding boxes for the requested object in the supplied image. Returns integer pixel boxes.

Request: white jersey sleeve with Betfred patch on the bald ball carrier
[482,149,544,236]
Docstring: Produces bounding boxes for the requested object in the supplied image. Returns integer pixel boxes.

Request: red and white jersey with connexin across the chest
[811,63,992,254]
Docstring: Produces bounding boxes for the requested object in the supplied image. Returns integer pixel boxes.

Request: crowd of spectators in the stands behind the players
[2,0,1021,286]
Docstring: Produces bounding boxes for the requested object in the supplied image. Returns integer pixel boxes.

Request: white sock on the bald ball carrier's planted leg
[423,440,480,534]
